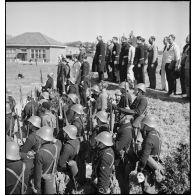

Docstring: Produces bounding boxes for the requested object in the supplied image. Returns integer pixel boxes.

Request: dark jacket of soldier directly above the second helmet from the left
[21,100,39,121]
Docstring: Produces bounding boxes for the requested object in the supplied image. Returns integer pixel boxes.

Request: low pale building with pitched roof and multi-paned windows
[6,32,66,63]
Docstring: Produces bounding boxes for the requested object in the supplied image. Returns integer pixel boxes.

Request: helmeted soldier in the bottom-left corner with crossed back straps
[6,141,33,194]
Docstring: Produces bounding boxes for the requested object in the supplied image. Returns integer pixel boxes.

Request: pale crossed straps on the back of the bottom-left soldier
[6,163,27,194]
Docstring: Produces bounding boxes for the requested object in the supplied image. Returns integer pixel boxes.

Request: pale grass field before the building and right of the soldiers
[6,55,190,161]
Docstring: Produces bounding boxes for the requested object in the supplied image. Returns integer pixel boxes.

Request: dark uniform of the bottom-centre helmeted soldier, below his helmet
[96,147,114,194]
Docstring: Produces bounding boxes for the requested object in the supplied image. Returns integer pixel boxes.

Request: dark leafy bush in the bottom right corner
[160,143,190,194]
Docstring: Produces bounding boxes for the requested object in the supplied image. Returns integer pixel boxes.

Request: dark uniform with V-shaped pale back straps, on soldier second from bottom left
[34,140,62,194]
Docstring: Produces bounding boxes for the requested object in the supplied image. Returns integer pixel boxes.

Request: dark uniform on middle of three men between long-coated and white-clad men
[111,43,121,82]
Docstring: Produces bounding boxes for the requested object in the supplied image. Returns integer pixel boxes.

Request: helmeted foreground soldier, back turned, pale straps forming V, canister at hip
[34,126,62,194]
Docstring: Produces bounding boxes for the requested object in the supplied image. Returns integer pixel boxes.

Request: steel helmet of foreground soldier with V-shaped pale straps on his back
[36,126,54,141]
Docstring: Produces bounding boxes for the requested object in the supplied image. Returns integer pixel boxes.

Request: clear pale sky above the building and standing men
[6,1,189,49]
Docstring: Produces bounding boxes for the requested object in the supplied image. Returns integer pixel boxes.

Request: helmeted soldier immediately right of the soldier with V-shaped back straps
[58,125,80,172]
